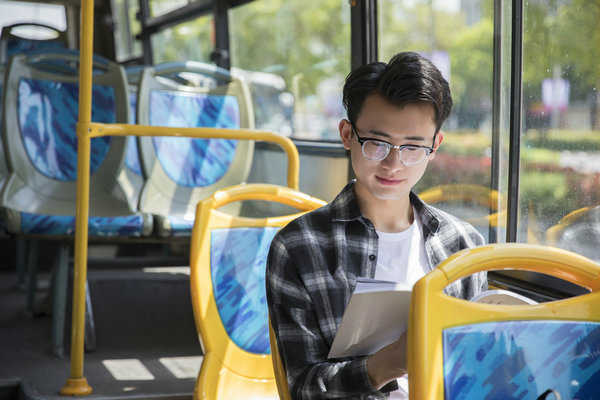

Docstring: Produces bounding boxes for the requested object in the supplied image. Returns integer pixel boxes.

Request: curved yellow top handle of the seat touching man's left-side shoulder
[210,183,326,211]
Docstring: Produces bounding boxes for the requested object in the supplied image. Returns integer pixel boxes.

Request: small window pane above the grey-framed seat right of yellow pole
[151,16,214,64]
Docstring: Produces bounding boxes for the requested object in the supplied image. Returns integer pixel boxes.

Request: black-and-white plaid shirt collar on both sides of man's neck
[331,180,440,233]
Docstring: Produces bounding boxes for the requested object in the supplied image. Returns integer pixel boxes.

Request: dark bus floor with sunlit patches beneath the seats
[0,245,202,400]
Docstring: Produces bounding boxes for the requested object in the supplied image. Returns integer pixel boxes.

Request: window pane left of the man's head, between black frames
[229,0,350,141]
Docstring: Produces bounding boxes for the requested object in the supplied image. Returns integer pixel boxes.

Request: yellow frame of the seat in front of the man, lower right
[408,243,600,400]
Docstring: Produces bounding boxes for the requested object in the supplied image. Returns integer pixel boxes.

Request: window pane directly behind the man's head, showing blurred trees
[377,0,500,241]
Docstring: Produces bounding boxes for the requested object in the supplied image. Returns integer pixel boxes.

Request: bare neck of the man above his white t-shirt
[354,186,415,233]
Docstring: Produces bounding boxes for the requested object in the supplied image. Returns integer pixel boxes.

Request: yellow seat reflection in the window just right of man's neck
[419,183,506,241]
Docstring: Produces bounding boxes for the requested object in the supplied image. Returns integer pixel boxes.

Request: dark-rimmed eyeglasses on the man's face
[350,122,437,167]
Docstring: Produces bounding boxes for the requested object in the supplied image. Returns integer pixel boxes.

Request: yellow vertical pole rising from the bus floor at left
[60,0,94,396]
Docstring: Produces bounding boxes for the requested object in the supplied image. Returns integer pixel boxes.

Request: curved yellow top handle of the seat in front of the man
[435,243,600,291]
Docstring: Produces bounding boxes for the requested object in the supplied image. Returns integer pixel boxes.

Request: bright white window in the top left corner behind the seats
[0,1,67,32]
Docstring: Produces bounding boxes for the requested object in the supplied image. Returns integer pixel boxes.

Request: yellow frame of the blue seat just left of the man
[190,184,325,399]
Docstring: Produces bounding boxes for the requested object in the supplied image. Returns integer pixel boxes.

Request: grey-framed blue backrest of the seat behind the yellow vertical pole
[0,50,141,223]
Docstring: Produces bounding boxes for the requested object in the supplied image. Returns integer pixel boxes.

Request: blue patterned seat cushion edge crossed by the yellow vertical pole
[21,212,144,237]
